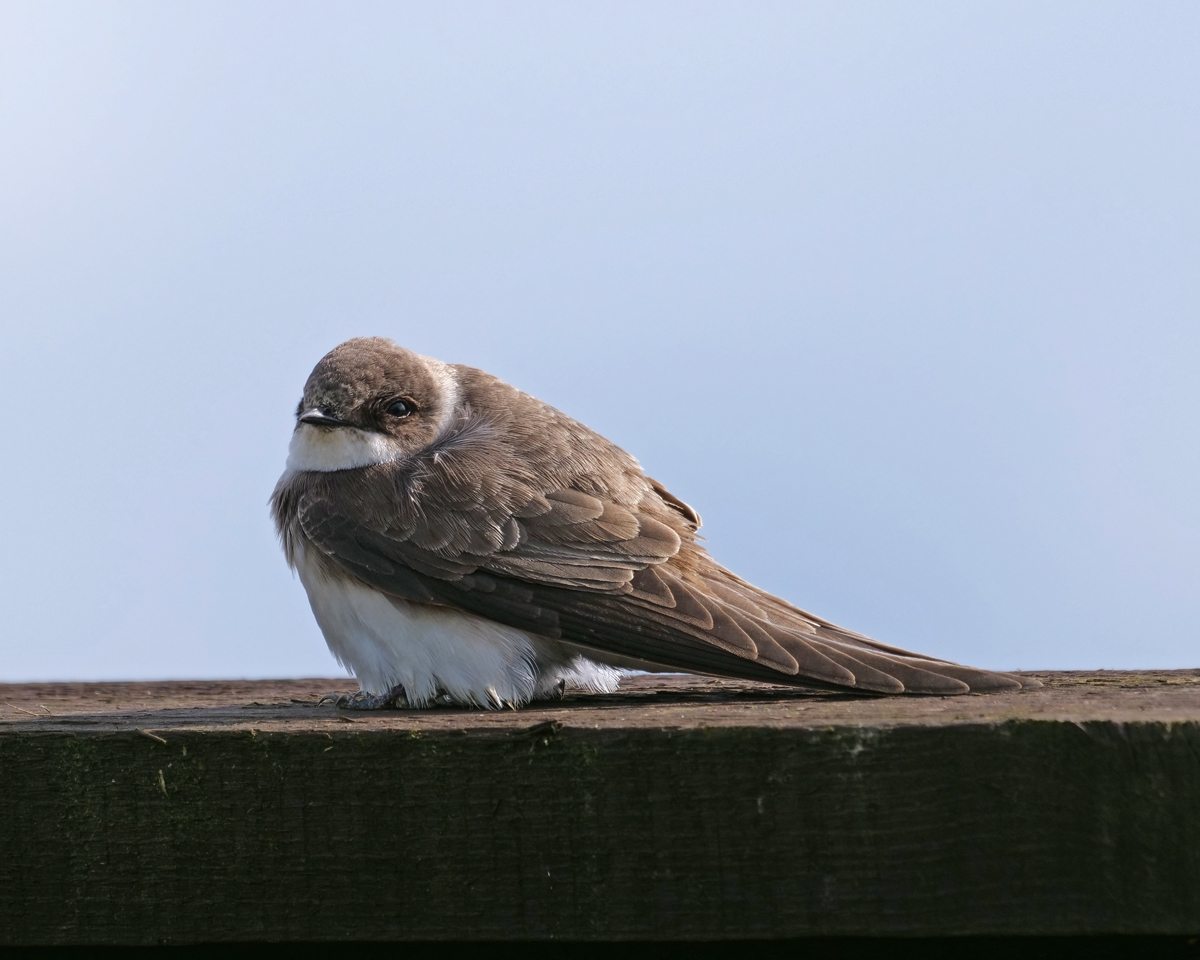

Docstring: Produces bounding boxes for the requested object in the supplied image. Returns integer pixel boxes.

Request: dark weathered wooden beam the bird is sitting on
[0,671,1200,943]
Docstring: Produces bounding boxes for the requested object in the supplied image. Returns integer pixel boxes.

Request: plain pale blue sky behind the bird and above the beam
[0,0,1200,680]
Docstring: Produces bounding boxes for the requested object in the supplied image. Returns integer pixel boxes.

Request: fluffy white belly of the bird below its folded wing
[296,548,624,708]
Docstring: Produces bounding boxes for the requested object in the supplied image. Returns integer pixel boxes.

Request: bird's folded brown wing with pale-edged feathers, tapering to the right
[289,460,1021,695]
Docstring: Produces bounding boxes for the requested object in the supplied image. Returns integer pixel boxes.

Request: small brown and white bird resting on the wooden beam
[270,337,1038,709]
